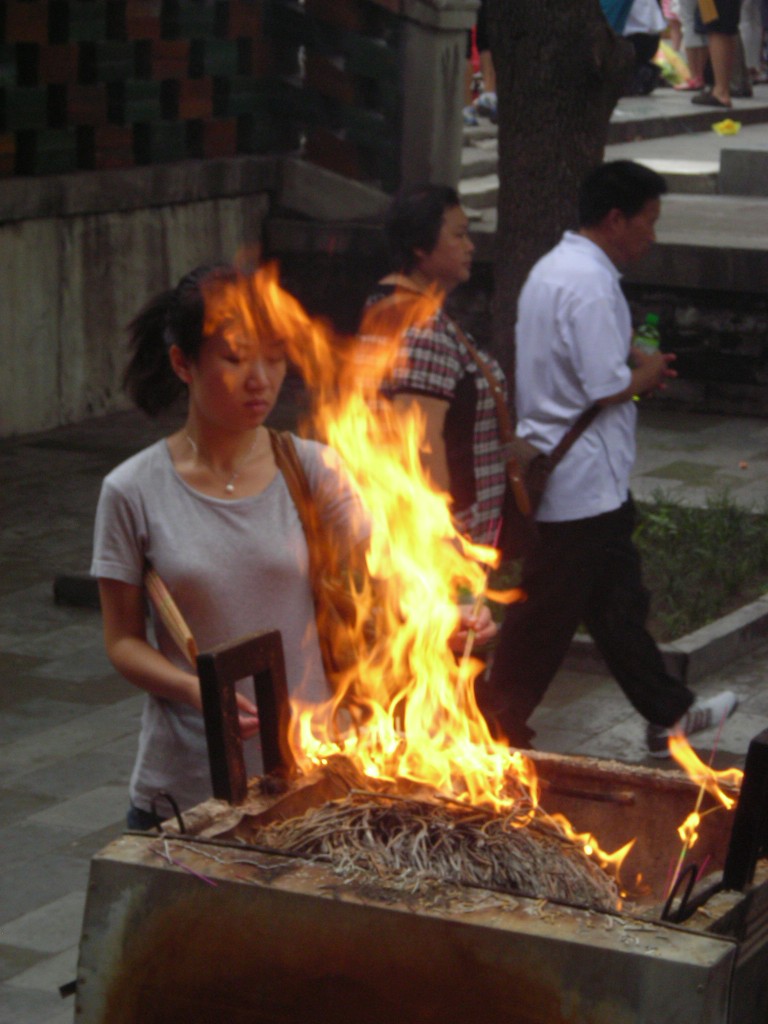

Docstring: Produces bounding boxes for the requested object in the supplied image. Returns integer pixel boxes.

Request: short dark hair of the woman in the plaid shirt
[384,184,461,273]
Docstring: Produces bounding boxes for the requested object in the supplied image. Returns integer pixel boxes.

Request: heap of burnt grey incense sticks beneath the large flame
[251,765,618,910]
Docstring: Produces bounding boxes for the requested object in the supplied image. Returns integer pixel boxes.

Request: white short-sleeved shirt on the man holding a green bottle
[515,231,637,522]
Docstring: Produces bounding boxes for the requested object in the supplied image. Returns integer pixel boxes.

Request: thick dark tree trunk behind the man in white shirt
[486,0,632,389]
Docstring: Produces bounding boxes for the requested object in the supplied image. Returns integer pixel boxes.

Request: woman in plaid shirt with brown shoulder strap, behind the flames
[366,184,506,544]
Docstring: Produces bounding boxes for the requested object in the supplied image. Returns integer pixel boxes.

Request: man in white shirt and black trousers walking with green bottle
[478,161,737,757]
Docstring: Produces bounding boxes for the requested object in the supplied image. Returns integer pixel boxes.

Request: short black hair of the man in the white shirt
[579,160,667,227]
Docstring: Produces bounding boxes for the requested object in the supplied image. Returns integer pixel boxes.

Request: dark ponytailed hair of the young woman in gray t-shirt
[123,263,241,416]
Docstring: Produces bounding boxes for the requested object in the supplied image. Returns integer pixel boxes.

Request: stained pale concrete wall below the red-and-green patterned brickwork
[0,160,274,436]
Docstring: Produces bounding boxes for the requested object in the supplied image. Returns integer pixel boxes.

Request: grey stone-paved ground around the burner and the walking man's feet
[0,99,768,1024]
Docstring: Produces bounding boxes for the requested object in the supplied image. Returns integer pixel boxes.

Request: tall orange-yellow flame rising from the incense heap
[218,266,631,884]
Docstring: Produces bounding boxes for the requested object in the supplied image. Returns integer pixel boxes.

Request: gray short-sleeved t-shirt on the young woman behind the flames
[91,437,369,810]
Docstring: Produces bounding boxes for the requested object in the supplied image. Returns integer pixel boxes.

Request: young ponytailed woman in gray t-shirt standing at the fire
[91,266,368,827]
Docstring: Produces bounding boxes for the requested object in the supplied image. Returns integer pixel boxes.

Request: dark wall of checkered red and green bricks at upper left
[0,0,399,187]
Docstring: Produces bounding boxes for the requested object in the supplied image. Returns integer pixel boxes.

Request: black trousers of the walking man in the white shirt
[477,498,693,746]
